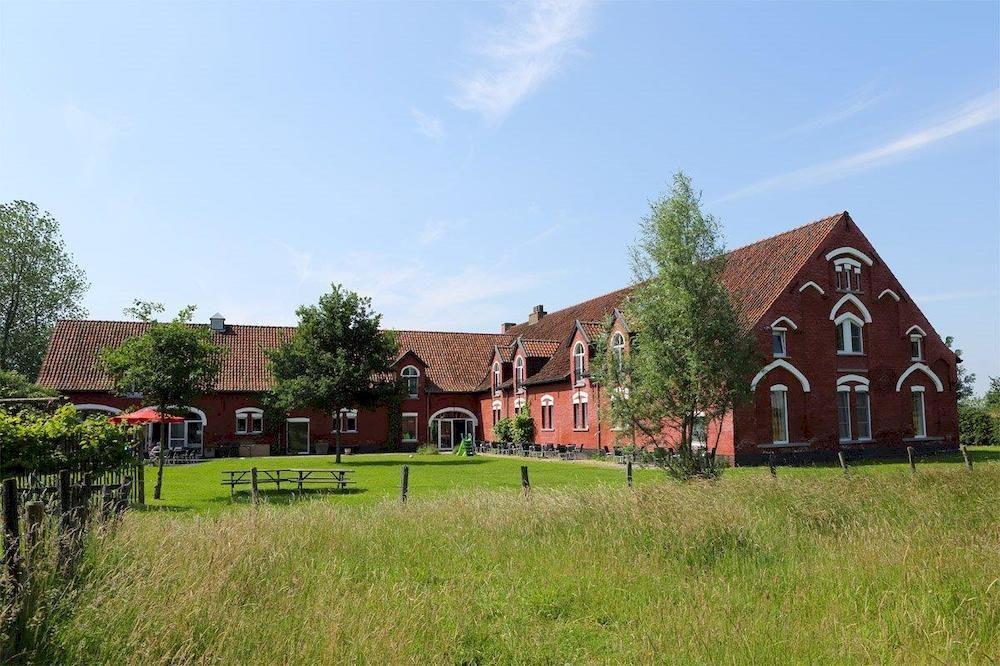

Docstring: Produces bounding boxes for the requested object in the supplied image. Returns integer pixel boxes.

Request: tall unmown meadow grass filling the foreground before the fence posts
[17,460,1000,664]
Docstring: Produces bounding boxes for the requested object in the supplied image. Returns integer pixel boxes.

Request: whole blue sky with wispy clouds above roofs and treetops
[0,2,1000,387]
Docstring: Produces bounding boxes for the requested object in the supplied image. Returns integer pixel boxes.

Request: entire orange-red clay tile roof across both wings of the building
[38,212,848,392]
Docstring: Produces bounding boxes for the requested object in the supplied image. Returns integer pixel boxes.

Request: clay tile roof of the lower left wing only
[38,320,511,393]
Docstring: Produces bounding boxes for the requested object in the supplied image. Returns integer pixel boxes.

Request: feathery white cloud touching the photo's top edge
[451,0,593,122]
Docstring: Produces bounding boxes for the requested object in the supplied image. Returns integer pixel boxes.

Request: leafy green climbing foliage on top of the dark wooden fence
[0,405,134,476]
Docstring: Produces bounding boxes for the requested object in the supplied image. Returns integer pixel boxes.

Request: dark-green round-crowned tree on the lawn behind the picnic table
[268,284,399,463]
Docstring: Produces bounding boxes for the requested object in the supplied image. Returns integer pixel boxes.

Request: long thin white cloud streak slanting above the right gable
[712,90,1000,203]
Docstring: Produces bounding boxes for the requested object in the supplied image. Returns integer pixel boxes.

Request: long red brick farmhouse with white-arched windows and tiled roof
[39,212,960,462]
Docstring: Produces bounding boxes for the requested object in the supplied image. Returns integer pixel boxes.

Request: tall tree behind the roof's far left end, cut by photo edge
[0,201,88,377]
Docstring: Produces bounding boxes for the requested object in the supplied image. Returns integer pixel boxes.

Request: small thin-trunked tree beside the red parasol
[100,301,224,499]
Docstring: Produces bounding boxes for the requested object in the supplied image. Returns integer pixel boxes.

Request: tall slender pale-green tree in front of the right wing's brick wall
[592,172,756,478]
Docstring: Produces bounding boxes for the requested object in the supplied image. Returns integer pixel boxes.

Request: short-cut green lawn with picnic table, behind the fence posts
[146,448,1000,514]
